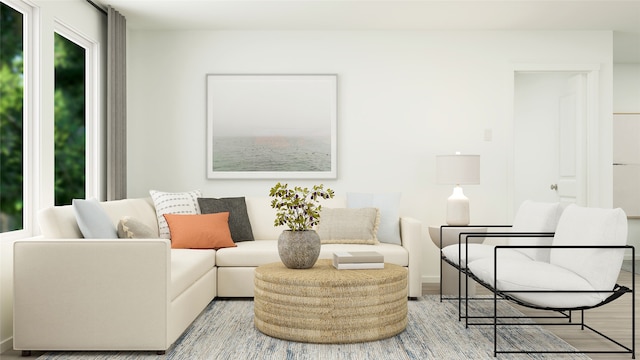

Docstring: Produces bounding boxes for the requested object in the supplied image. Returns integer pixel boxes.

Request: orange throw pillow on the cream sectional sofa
[163,212,236,249]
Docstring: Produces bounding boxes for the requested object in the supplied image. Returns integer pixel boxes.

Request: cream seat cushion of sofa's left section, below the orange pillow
[169,249,216,300]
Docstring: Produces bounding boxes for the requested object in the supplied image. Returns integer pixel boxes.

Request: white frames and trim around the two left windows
[0,0,106,243]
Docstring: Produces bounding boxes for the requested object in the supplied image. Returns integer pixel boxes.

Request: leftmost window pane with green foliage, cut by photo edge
[0,3,25,233]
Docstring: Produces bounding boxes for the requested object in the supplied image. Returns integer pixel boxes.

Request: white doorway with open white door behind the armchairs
[513,71,586,211]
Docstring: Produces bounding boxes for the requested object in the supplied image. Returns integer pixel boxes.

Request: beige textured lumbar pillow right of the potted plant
[317,207,380,245]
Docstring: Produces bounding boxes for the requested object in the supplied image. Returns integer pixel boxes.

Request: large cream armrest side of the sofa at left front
[13,239,171,350]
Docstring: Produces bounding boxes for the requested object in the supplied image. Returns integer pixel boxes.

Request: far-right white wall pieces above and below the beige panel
[613,64,640,258]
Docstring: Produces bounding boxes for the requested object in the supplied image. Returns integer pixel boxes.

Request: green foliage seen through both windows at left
[0,3,86,232]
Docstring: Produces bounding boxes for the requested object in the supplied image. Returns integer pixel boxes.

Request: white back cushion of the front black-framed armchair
[550,204,628,290]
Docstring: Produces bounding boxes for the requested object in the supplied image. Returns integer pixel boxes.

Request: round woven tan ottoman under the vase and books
[254,260,407,344]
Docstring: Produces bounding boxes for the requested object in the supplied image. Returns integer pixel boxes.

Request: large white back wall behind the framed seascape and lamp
[127,30,612,281]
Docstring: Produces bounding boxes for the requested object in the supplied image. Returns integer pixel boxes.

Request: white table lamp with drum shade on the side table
[436,153,480,225]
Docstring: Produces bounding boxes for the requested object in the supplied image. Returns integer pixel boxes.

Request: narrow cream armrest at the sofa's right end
[400,217,423,297]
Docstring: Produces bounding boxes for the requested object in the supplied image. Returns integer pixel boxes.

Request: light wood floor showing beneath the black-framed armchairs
[422,271,640,360]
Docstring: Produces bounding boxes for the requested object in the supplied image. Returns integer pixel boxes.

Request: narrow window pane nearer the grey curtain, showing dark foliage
[54,33,86,205]
